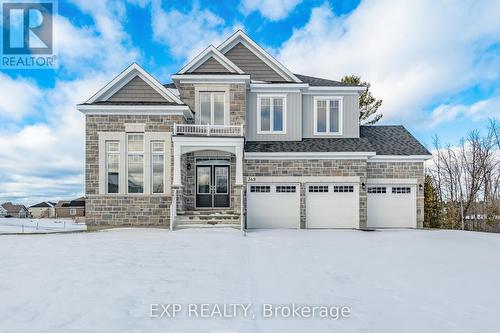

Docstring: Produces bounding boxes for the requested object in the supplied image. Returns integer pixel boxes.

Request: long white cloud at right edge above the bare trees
[427,96,500,128]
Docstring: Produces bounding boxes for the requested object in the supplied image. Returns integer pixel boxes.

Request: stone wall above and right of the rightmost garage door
[367,162,424,228]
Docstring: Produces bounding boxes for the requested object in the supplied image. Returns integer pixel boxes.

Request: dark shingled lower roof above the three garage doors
[245,126,430,156]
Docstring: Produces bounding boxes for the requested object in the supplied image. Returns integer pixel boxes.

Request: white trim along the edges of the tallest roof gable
[217,30,302,82]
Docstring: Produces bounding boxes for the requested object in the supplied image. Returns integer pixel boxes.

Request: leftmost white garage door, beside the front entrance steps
[247,183,300,229]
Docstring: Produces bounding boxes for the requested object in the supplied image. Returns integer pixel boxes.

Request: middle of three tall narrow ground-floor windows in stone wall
[127,133,144,193]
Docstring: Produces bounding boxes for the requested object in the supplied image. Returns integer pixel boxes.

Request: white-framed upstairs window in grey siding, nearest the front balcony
[257,94,286,134]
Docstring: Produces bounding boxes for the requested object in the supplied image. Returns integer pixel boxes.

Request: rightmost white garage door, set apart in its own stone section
[367,185,417,228]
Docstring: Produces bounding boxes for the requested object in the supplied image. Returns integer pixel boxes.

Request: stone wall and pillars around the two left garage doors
[244,160,367,229]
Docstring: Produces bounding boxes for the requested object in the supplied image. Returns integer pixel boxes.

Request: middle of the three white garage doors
[306,183,359,228]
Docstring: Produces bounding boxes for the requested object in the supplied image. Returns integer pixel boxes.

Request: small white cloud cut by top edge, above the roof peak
[240,0,302,21]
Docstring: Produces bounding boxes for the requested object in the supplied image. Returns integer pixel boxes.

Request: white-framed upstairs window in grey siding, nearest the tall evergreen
[314,96,343,135]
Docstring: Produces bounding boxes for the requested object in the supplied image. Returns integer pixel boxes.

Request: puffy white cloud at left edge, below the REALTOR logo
[0,73,41,121]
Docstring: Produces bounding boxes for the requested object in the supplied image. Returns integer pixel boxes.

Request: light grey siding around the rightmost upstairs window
[302,94,359,138]
